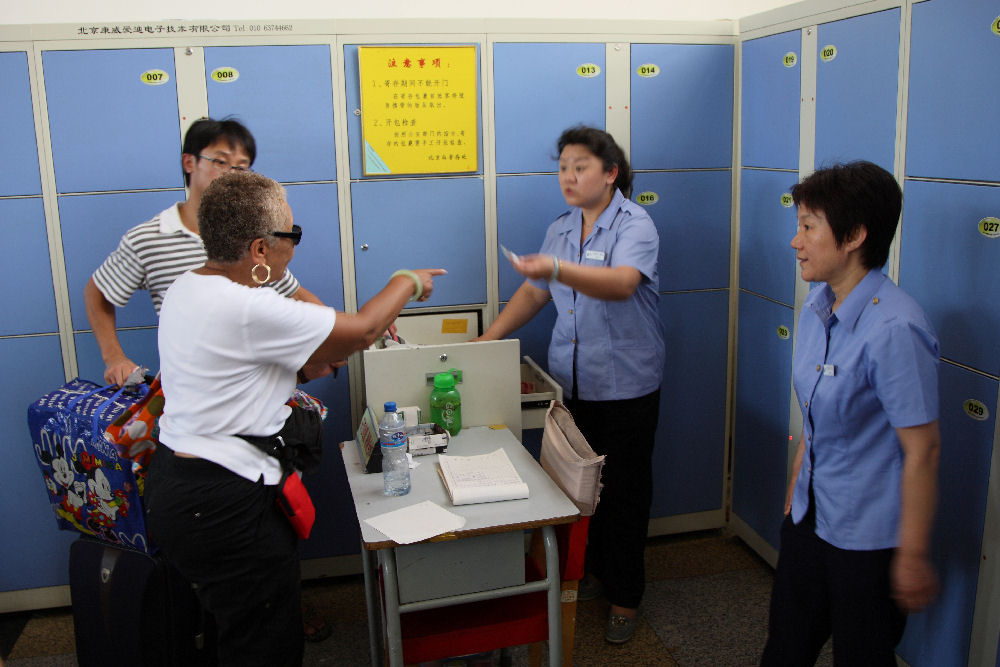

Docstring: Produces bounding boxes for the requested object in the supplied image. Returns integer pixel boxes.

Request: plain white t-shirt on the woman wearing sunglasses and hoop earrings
[159,272,336,484]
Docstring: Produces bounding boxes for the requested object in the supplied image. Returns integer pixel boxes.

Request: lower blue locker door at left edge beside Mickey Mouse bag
[0,336,76,591]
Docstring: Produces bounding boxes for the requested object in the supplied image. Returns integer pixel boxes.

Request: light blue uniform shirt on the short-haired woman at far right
[792,269,939,551]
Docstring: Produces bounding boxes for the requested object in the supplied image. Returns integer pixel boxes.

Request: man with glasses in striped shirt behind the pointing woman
[84,118,329,385]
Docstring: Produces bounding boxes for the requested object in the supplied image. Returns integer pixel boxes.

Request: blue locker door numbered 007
[42,49,184,192]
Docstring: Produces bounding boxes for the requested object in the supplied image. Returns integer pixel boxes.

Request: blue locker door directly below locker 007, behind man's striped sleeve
[59,190,184,332]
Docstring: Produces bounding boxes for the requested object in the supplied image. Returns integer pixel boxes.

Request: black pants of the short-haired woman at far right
[761,517,906,667]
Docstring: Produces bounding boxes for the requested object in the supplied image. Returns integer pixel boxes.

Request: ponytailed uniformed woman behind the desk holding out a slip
[480,127,664,643]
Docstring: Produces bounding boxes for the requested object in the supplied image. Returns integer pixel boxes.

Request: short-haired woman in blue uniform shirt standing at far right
[762,162,940,667]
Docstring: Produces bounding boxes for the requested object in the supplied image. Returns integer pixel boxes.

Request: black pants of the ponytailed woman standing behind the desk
[566,389,660,609]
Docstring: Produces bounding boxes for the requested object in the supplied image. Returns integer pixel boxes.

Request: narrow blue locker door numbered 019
[741,30,802,170]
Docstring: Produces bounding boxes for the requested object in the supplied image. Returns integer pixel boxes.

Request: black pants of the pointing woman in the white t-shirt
[145,446,303,666]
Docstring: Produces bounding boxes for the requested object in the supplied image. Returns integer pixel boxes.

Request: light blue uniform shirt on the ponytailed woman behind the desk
[529,190,664,401]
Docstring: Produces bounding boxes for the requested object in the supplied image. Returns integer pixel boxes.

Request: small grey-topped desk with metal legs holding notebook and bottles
[341,426,580,667]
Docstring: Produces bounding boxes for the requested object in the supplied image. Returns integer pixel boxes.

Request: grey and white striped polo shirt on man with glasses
[94,204,299,315]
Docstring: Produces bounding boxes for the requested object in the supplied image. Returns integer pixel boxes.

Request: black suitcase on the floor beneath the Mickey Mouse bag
[69,537,218,667]
